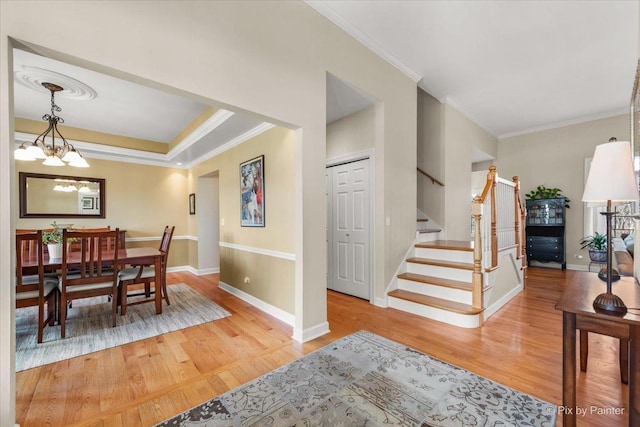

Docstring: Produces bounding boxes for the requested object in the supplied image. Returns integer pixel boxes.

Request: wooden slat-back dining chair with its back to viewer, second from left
[58,228,120,338]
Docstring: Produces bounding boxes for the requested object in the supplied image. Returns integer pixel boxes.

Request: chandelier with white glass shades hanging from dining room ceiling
[14,82,89,168]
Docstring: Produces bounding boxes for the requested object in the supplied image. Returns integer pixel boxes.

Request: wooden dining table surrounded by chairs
[22,246,163,314]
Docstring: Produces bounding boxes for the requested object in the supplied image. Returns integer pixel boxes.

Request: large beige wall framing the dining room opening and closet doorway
[0,1,416,419]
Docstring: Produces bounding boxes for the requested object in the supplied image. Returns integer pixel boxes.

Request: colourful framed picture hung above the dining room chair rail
[240,156,264,227]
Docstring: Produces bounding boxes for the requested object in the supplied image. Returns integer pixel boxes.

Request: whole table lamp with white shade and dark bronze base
[582,138,638,316]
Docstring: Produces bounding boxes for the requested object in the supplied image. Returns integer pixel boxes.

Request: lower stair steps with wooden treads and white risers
[388,241,489,328]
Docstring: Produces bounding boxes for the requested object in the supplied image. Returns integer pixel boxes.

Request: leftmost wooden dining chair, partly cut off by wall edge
[16,230,58,344]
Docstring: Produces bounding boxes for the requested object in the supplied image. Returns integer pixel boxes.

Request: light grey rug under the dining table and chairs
[16,284,230,372]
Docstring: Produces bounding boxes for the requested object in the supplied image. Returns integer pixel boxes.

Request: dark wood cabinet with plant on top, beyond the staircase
[526,198,567,270]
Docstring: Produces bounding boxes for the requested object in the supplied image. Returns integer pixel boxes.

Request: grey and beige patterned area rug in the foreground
[158,331,556,427]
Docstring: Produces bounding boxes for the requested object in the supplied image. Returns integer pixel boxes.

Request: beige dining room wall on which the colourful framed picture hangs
[190,127,296,314]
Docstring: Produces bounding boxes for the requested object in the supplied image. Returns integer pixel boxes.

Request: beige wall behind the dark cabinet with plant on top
[496,114,630,265]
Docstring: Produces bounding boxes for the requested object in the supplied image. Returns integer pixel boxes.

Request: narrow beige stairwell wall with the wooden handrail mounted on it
[417,89,446,225]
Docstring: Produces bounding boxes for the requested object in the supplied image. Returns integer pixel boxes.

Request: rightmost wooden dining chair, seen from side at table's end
[118,225,175,316]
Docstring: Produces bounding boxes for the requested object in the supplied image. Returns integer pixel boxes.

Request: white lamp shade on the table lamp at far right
[582,141,638,202]
